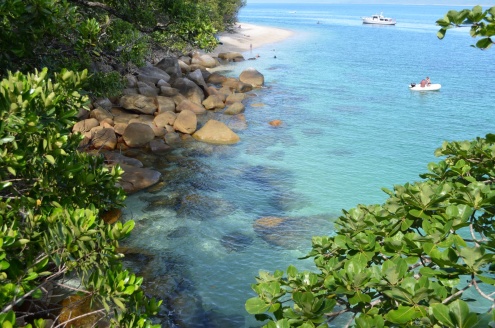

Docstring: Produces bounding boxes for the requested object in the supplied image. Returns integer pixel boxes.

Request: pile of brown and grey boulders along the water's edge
[73,52,264,194]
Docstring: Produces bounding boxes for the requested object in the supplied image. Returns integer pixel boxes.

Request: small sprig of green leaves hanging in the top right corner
[437,6,495,49]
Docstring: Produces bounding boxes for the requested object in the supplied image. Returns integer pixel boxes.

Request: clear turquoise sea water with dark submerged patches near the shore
[124,4,495,327]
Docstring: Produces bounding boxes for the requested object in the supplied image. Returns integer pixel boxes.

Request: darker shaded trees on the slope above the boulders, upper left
[0,0,245,92]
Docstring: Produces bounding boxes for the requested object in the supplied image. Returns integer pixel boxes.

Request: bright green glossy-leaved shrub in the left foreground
[0,69,161,327]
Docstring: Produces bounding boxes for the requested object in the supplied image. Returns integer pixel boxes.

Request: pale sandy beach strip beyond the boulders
[212,23,294,54]
